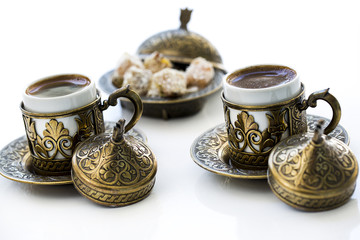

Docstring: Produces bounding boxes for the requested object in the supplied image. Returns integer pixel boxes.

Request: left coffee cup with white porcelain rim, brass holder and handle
[20,74,142,175]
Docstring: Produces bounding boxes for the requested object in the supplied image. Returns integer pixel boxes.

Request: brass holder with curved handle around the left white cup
[20,74,142,175]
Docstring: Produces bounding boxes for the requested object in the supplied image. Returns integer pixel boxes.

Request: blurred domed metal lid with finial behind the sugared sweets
[137,9,225,71]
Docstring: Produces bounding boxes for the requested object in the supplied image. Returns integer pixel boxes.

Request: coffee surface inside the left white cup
[26,75,90,98]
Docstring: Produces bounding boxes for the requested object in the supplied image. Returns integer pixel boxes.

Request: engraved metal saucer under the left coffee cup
[0,122,147,185]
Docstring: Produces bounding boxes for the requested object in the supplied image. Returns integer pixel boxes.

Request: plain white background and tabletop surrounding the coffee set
[0,0,360,239]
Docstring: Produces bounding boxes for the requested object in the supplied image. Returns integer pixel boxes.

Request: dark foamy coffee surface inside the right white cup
[227,65,297,88]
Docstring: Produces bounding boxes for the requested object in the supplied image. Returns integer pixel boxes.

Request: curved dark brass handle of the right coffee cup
[299,88,341,134]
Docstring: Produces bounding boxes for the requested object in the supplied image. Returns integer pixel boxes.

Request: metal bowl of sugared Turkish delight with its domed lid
[99,9,226,119]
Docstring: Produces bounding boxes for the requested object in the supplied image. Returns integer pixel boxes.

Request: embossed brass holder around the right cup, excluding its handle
[223,96,307,168]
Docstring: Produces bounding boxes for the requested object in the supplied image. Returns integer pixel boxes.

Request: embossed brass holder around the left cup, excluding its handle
[22,98,105,175]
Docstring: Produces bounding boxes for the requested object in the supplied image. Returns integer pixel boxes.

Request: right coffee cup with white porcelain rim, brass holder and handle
[221,65,341,169]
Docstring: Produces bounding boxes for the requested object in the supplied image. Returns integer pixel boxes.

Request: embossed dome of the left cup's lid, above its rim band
[76,136,154,186]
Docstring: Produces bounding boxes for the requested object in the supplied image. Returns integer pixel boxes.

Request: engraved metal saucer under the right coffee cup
[190,114,349,179]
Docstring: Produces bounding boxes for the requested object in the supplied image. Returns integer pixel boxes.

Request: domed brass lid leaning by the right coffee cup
[268,121,358,211]
